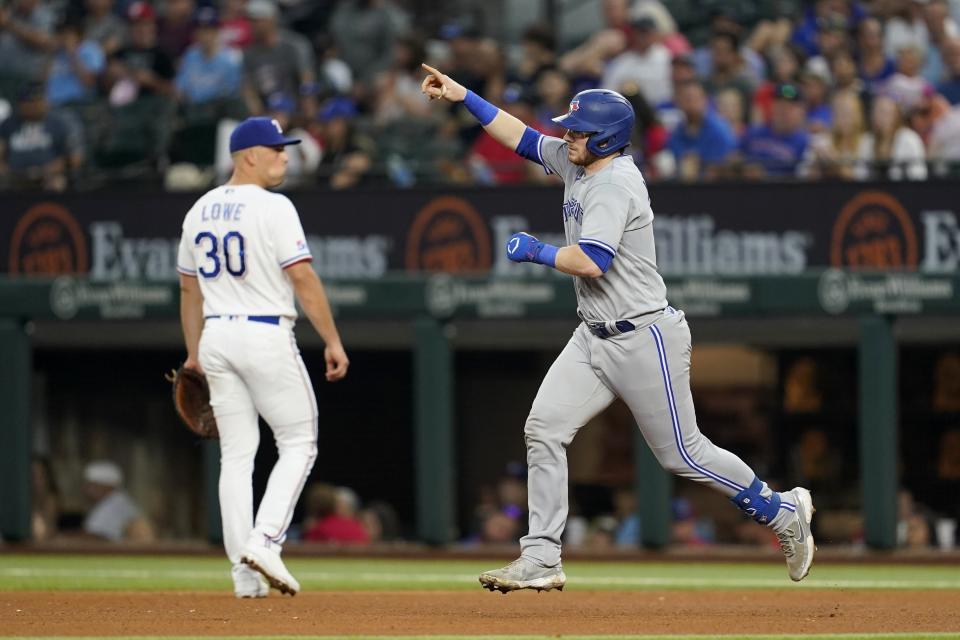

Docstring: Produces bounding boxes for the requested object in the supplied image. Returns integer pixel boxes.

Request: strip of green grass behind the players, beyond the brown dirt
[0,555,960,597]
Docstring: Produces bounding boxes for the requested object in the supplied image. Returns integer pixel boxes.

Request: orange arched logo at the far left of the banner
[8,202,89,276]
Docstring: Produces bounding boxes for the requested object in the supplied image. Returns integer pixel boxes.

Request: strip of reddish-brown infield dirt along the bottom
[0,588,960,637]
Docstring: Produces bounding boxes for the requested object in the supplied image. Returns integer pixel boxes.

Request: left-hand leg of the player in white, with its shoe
[200,323,266,598]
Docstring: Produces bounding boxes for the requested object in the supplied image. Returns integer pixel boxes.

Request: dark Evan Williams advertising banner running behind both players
[0,182,960,282]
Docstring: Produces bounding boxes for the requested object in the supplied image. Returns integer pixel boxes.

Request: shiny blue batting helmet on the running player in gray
[553,89,634,157]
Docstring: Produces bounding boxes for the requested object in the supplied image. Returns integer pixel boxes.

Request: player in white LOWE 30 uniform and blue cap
[177,118,349,598]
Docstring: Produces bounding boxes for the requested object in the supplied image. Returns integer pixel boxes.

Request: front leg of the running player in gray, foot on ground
[480,326,614,593]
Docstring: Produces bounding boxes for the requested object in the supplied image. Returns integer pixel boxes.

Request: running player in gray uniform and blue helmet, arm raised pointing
[421,65,816,593]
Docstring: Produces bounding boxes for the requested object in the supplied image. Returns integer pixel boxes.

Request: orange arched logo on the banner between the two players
[406,196,490,273]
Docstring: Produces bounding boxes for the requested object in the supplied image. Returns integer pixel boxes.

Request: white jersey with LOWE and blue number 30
[177,184,313,319]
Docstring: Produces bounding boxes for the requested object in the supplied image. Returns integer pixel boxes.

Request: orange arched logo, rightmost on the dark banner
[830,191,918,269]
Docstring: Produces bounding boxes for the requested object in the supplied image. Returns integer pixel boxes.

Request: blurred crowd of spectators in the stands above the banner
[0,0,960,190]
